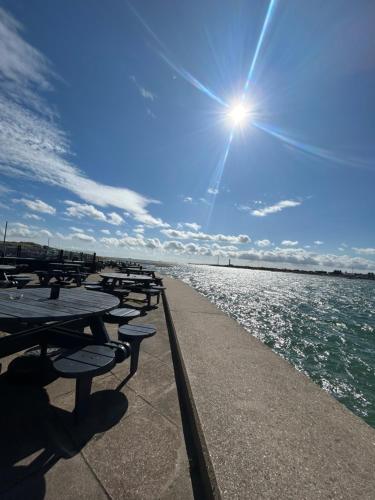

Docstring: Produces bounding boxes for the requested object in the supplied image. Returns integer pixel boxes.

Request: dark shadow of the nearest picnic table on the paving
[0,373,128,500]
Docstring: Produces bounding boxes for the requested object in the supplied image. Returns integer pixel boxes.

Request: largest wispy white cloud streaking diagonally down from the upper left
[0,9,167,227]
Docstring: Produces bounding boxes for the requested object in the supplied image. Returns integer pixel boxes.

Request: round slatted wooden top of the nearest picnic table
[0,288,120,323]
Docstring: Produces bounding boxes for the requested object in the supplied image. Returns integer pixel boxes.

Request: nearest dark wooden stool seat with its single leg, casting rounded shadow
[52,344,116,420]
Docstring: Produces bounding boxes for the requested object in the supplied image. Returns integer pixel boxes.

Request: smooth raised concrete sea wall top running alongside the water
[164,278,375,500]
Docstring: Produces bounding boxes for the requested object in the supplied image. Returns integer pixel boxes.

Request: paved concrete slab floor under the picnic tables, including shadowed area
[0,276,199,500]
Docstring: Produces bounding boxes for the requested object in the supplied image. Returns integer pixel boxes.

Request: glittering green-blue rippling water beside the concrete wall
[162,265,375,427]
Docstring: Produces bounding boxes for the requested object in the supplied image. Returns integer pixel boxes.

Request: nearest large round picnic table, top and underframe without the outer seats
[0,288,119,358]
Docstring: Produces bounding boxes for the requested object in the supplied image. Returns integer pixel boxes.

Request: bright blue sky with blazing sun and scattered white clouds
[0,0,375,270]
